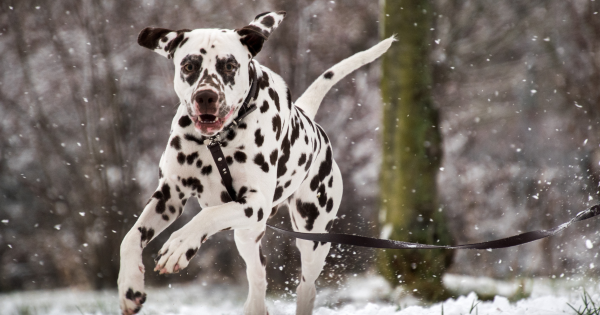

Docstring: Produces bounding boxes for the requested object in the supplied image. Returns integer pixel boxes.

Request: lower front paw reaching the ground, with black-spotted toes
[118,263,146,315]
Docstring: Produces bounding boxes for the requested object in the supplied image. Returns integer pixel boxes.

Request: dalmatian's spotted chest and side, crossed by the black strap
[160,69,323,207]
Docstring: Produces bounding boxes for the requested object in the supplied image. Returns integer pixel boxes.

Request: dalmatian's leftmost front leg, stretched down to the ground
[117,178,188,315]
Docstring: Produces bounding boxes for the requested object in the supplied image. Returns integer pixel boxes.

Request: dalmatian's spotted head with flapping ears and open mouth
[138,11,285,136]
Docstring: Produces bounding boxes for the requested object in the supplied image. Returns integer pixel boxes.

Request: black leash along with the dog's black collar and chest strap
[207,63,600,249]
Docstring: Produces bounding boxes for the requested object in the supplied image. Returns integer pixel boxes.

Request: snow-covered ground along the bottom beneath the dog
[0,275,600,315]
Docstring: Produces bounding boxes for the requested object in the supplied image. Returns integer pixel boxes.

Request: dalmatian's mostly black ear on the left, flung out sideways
[138,27,190,59]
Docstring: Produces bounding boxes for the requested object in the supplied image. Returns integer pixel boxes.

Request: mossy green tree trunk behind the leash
[378,1,452,300]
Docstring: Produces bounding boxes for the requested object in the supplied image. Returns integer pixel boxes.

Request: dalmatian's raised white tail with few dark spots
[295,35,396,118]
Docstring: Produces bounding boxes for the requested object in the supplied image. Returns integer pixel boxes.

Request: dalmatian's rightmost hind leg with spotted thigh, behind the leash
[289,162,343,315]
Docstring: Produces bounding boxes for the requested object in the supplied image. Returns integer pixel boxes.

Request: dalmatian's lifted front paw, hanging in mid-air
[154,231,207,274]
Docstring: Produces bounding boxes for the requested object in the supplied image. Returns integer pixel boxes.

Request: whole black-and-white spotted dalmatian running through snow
[118,11,394,315]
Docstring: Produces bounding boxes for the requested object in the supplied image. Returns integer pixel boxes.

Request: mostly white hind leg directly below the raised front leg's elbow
[234,229,267,315]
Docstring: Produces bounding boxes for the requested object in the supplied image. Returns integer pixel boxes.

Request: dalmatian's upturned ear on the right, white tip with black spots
[235,11,285,56]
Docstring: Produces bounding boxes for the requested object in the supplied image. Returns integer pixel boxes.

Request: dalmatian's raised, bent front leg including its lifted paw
[155,190,273,274]
